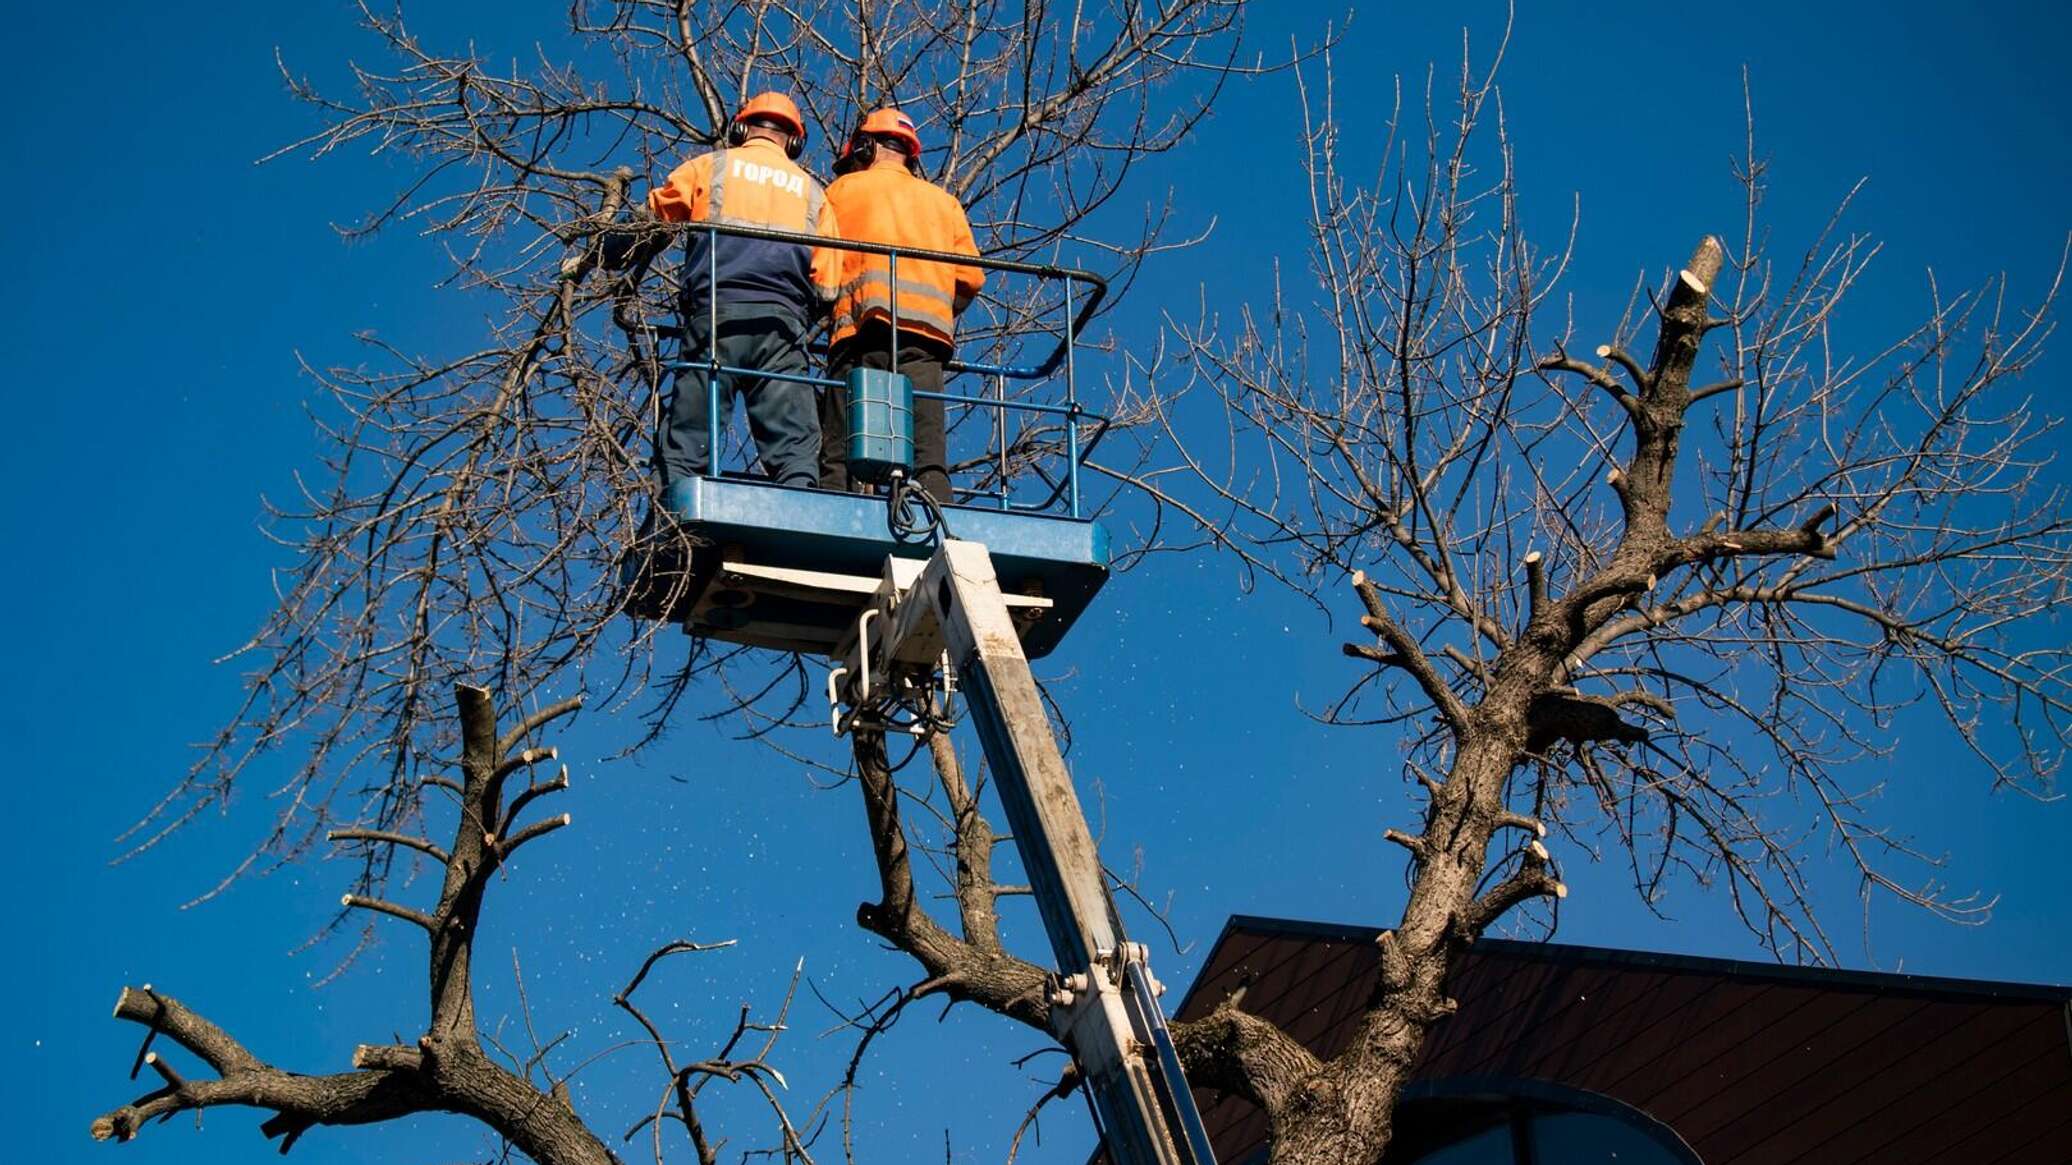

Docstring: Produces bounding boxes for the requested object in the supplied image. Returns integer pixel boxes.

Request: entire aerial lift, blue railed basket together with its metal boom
[626,224,1214,1165]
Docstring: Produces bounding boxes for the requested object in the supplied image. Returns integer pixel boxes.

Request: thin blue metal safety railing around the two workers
[657,222,1111,518]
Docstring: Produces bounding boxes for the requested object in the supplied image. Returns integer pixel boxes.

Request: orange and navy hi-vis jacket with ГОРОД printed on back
[649,139,841,319]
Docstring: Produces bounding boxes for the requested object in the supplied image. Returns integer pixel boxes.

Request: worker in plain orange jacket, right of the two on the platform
[821,108,986,502]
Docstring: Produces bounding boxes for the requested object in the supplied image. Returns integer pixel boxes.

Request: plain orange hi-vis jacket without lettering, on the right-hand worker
[827,166,986,344]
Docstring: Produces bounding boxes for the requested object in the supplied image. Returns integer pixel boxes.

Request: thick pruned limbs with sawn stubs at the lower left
[93,684,812,1165]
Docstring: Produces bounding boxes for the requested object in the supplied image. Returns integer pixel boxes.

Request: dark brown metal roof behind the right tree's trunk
[1179,916,2072,1165]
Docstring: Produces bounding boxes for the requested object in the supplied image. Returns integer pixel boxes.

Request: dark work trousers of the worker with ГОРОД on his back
[655,305,821,487]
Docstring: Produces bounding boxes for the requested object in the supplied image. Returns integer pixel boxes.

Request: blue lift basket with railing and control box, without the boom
[620,222,1109,657]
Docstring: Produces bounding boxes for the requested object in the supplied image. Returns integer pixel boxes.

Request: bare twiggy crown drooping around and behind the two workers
[128,0,1247,916]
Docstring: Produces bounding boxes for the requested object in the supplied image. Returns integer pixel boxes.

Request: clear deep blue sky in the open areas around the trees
[0,0,2072,1163]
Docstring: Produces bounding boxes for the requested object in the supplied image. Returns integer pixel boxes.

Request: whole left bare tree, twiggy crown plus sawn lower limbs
[95,0,1292,1163]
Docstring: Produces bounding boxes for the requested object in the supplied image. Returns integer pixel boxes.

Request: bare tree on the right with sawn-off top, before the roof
[1111,43,2072,1165]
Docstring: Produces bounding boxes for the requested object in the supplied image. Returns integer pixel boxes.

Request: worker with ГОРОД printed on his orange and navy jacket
[649,93,839,493]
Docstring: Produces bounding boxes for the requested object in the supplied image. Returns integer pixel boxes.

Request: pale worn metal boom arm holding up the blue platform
[827,539,1214,1165]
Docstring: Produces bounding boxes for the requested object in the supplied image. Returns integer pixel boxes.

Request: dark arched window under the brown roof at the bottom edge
[1380,1078,1703,1165]
